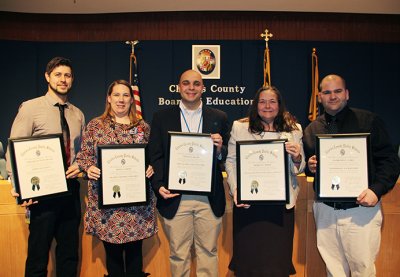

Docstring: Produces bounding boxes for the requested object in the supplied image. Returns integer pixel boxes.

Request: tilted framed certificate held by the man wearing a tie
[8,134,69,204]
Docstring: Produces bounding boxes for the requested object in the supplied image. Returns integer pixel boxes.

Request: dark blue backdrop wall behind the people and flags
[0,40,400,148]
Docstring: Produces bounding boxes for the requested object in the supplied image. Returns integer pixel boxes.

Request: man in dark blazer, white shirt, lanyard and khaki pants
[149,70,229,276]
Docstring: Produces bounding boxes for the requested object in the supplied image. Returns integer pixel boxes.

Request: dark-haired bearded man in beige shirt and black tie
[7,57,85,277]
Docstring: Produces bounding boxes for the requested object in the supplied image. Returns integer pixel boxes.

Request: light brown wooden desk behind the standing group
[0,177,400,277]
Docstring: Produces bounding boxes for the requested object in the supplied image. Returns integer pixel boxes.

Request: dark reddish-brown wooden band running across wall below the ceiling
[0,12,400,43]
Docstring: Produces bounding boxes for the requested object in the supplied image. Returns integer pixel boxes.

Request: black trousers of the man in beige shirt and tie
[25,180,81,277]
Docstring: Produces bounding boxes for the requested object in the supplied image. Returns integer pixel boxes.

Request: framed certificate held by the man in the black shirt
[315,133,370,202]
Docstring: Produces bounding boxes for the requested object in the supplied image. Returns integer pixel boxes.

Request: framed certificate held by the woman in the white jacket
[236,139,289,204]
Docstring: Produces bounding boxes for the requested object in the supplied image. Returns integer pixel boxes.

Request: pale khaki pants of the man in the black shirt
[313,202,382,277]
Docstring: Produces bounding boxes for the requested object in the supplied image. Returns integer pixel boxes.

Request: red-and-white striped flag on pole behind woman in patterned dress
[125,40,143,119]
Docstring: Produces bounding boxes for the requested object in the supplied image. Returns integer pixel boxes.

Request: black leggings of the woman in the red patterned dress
[103,240,144,277]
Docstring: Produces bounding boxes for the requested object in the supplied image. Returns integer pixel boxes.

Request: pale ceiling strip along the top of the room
[0,0,400,14]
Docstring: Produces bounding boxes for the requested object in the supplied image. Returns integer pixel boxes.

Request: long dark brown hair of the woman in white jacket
[248,86,299,134]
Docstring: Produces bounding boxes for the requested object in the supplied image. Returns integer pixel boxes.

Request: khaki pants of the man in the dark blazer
[162,195,222,277]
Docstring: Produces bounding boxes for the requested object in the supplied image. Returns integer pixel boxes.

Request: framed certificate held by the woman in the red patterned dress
[97,144,148,208]
